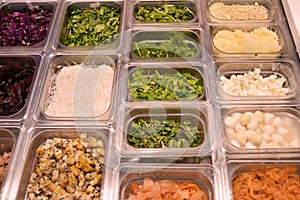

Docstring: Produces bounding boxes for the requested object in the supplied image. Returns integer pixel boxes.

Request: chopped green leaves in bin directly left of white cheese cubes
[128,69,204,100]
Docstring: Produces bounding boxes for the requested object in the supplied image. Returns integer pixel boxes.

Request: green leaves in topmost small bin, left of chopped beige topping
[133,4,193,22]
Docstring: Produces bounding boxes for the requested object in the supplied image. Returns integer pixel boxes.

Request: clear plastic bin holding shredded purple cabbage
[0,0,59,53]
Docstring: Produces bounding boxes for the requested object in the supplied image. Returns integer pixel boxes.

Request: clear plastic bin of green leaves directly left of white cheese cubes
[118,62,210,102]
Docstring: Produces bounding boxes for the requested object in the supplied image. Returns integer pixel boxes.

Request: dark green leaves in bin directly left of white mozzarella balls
[127,119,204,148]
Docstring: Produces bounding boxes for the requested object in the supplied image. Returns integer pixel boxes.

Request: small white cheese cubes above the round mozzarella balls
[220,68,290,96]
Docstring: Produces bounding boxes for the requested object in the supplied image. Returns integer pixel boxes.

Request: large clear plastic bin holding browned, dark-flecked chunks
[10,127,112,199]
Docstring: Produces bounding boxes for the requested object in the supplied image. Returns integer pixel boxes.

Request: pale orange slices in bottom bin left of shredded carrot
[128,178,207,200]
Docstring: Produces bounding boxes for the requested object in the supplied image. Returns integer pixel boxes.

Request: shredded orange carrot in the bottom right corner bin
[232,167,300,200]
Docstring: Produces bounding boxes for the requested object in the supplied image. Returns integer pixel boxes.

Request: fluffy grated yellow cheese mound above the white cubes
[213,27,282,54]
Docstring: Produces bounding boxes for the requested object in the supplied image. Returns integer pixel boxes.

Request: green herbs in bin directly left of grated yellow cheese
[132,33,197,58]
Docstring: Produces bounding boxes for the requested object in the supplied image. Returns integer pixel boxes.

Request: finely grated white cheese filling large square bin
[45,64,114,117]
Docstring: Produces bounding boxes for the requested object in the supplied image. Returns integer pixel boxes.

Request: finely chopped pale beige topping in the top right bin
[209,2,269,20]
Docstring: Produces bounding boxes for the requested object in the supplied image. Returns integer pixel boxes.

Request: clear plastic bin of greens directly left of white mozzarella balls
[114,102,218,158]
